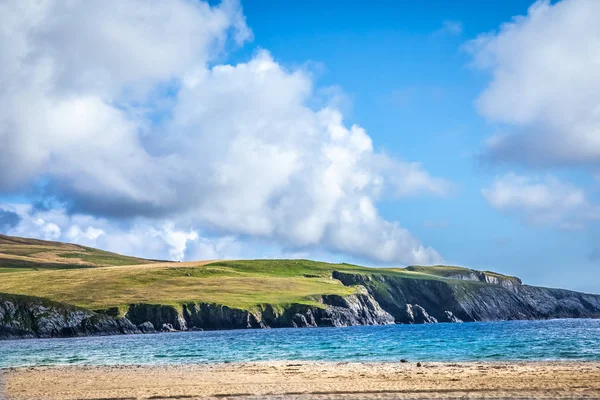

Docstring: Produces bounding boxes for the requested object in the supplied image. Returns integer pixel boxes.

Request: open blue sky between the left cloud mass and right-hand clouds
[234,0,600,290]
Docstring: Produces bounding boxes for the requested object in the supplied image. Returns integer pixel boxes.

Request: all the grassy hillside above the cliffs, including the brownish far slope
[0,236,502,309]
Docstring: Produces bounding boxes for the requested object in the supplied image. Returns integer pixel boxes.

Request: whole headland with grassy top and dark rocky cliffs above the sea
[0,235,600,337]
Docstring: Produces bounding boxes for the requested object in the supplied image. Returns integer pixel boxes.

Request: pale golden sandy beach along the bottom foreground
[3,361,600,400]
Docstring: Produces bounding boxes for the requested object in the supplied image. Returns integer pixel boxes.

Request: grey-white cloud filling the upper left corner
[0,0,250,193]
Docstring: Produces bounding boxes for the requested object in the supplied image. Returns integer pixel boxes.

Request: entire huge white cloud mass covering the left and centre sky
[0,0,450,263]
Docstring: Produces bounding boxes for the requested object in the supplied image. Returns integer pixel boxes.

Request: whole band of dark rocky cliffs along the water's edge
[0,271,600,339]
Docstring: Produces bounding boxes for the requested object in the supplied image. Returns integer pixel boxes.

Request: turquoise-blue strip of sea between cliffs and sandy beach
[0,319,600,368]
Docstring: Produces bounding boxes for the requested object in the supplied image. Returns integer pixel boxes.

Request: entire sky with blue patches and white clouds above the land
[0,0,600,293]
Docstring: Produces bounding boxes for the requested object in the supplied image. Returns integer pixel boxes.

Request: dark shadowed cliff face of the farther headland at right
[333,271,600,323]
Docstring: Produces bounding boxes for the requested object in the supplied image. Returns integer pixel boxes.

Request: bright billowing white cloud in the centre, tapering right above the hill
[159,51,448,263]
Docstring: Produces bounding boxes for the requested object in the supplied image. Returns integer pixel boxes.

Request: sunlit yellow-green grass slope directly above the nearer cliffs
[0,260,366,309]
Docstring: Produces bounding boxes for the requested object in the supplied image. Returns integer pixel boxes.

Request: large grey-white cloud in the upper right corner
[467,0,600,166]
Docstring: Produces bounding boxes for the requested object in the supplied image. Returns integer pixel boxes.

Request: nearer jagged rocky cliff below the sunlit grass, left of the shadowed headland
[0,290,394,339]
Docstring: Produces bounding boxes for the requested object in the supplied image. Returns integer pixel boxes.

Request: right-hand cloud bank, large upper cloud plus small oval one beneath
[474,0,600,244]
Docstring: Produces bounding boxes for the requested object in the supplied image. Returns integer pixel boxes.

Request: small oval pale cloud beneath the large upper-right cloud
[481,173,600,229]
